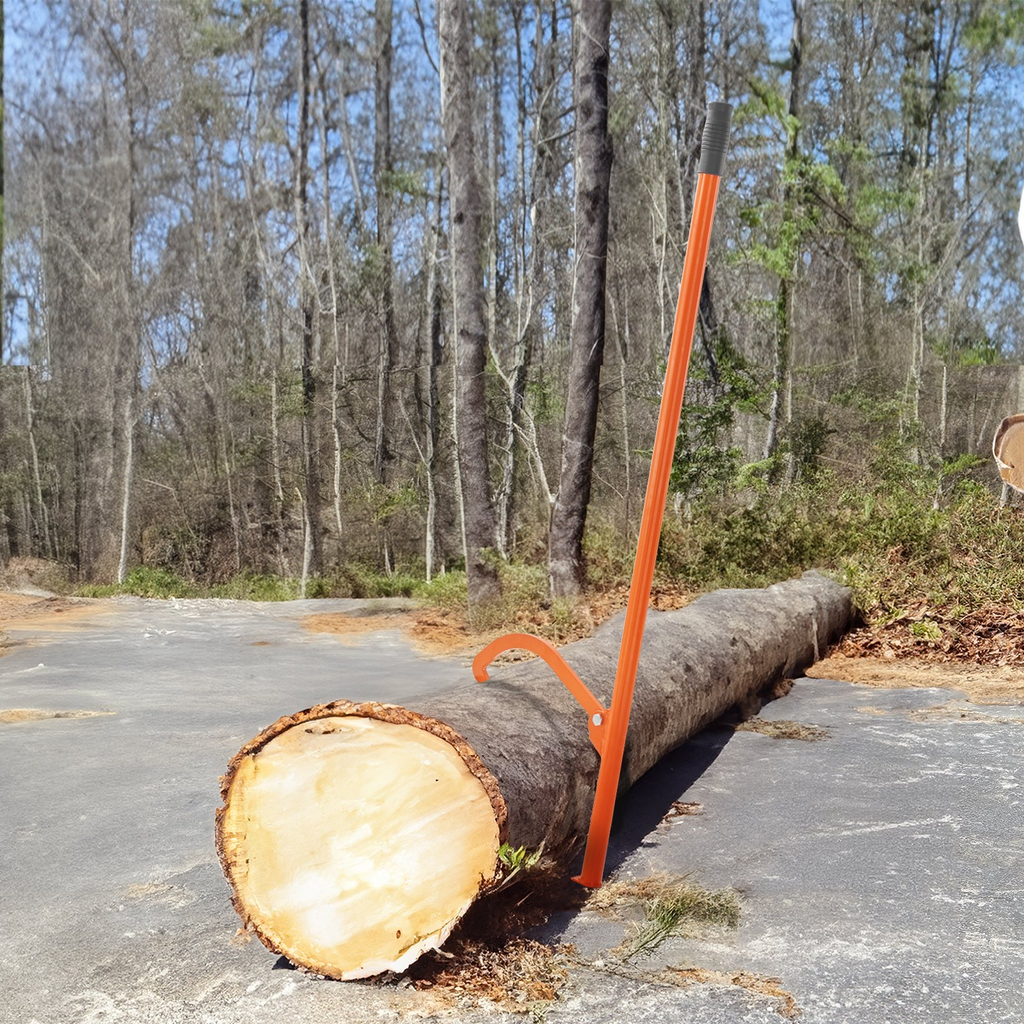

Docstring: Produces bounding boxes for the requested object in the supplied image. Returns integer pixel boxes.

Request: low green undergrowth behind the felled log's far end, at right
[658,445,1024,609]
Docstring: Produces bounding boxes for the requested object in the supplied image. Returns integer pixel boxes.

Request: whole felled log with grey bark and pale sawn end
[216,572,852,979]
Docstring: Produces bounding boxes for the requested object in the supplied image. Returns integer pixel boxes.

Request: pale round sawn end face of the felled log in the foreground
[217,706,504,979]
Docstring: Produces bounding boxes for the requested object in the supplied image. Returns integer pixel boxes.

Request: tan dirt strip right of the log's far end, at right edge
[806,654,1024,705]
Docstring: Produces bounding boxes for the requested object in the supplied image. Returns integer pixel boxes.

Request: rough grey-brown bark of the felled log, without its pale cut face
[217,572,853,976]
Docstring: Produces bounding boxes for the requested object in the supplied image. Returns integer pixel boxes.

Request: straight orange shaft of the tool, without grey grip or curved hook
[574,174,720,889]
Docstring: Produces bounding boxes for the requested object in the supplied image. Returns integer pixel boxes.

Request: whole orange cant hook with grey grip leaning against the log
[473,103,732,889]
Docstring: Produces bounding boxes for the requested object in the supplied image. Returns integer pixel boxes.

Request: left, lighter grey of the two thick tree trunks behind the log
[439,0,500,610]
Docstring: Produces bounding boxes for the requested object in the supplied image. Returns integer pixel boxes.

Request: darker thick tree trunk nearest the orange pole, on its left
[548,0,612,596]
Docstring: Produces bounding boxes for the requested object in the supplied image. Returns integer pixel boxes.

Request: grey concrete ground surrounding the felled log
[0,599,1024,1024]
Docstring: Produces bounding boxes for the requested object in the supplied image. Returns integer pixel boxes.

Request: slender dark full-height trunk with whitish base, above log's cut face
[296,0,324,574]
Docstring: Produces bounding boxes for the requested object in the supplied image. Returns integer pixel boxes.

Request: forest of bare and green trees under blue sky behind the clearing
[0,0,1024,643]
